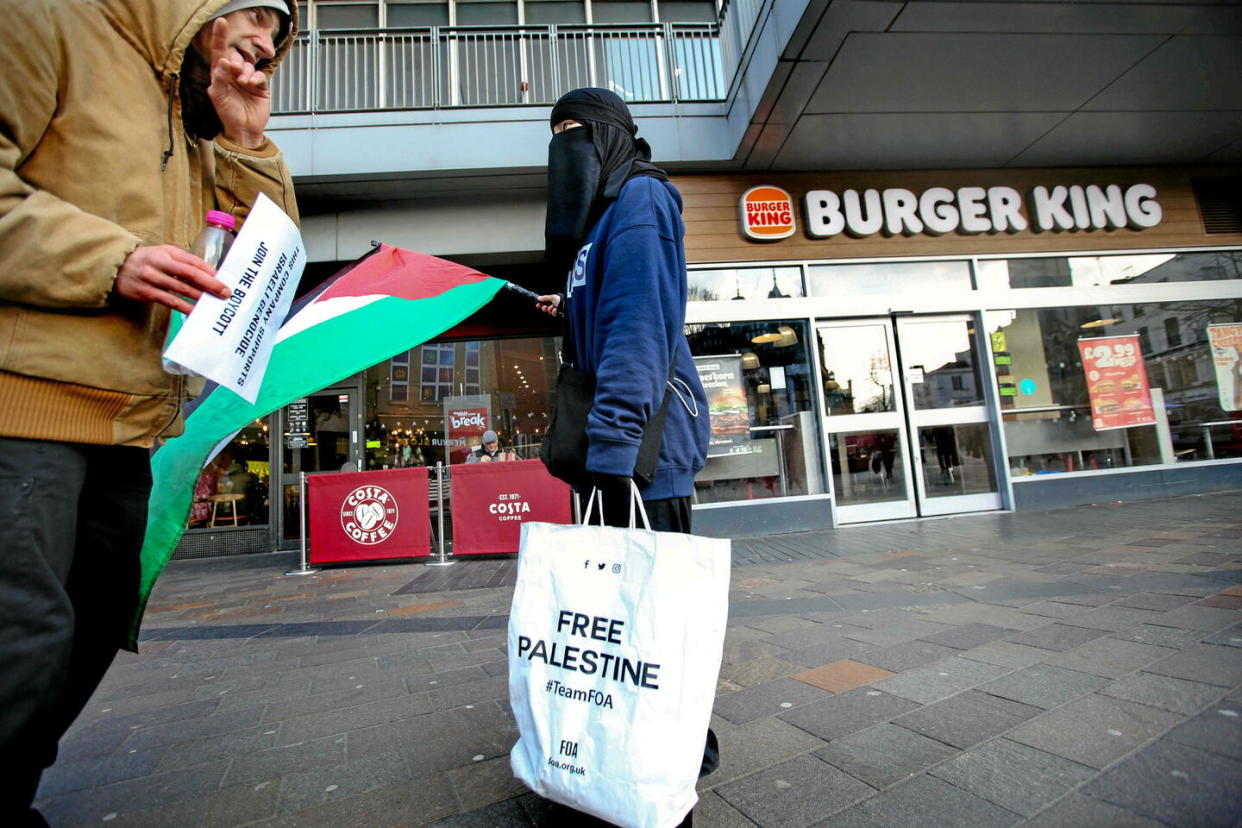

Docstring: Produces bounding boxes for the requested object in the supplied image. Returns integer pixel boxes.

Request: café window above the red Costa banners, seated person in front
[365,338,558,469]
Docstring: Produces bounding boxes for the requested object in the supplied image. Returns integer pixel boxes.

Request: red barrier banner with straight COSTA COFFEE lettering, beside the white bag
[450,461,570,556]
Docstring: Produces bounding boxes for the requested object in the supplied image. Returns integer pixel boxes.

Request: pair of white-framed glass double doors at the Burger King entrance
[818,315,1001,523]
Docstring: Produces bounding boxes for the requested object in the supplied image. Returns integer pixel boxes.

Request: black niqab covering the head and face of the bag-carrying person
[544,88,668,272]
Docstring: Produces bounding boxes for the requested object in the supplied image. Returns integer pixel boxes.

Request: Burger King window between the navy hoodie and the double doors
[688,319,825,503]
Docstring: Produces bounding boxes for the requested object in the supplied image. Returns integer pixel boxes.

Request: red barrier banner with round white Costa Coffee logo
[307,467,431,564]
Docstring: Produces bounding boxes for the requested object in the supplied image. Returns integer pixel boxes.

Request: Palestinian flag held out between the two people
[128,245,505,652]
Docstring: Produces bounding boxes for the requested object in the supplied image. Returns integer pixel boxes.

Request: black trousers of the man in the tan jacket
[0,437,152,826]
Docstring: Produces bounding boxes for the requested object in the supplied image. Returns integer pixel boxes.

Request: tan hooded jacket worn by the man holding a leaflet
[0,0,297,446]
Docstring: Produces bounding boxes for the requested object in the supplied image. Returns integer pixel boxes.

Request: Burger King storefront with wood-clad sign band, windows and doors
[678,168,1242,535]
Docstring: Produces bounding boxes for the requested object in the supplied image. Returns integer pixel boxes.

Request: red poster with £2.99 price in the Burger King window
[1078,334,1156,431]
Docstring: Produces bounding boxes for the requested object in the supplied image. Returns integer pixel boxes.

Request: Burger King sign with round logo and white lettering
[740,184,1164,241]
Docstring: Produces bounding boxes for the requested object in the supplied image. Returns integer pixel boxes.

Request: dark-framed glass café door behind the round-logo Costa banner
[278,387,363,547]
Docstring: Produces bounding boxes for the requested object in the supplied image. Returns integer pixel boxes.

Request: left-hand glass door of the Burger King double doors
[818,319,918,523]
